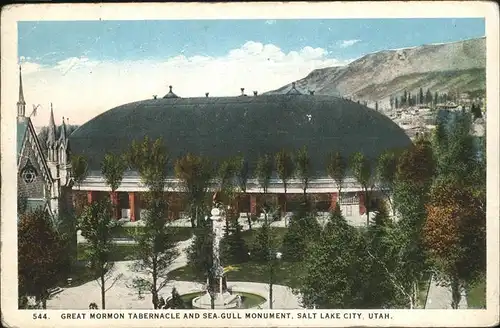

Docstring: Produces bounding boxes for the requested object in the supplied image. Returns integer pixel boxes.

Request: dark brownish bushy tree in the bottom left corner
[17,210,69,309]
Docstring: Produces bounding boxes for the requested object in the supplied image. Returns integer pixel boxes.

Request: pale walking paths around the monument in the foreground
[47,238,301,310]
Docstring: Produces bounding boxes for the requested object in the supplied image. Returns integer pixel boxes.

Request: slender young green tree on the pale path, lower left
[78,201,120,310]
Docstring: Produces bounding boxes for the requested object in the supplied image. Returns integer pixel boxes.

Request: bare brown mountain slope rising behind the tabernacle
[267,37,486,109]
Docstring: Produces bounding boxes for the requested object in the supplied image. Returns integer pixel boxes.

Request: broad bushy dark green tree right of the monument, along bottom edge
[297,207,376,309]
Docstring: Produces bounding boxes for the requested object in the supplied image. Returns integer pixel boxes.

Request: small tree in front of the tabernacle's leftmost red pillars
[101,153,127,220]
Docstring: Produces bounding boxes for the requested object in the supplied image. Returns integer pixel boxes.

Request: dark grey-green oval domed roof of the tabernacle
[70,95,411,175]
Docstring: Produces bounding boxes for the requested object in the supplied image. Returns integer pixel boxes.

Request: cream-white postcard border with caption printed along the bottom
[1,2,500,327]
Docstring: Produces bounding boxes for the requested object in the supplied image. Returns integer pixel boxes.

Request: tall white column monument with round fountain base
[192,204,241,309]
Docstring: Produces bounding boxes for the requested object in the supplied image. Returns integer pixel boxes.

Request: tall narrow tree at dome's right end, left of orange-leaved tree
[387,138,435,308]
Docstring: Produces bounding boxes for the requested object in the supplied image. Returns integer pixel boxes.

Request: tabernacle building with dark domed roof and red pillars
[69,85,411,221]
